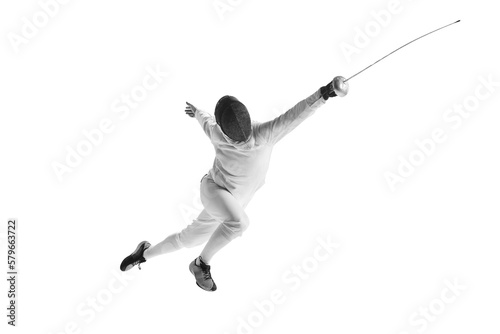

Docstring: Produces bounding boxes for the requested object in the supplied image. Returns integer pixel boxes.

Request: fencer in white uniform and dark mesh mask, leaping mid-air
[120,80,348,291]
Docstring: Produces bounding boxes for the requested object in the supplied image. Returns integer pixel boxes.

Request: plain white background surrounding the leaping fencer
[0,0,500,334]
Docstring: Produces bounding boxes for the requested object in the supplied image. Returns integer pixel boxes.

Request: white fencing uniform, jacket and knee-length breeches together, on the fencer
[172,90,325,254]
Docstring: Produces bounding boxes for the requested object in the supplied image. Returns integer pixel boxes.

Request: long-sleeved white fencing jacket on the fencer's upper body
[195,90,325,199]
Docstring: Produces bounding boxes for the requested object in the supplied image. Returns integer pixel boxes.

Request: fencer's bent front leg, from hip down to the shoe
[200,177,249,264]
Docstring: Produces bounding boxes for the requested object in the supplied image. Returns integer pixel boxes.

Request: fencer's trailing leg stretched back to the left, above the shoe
[144,210,219,260]
